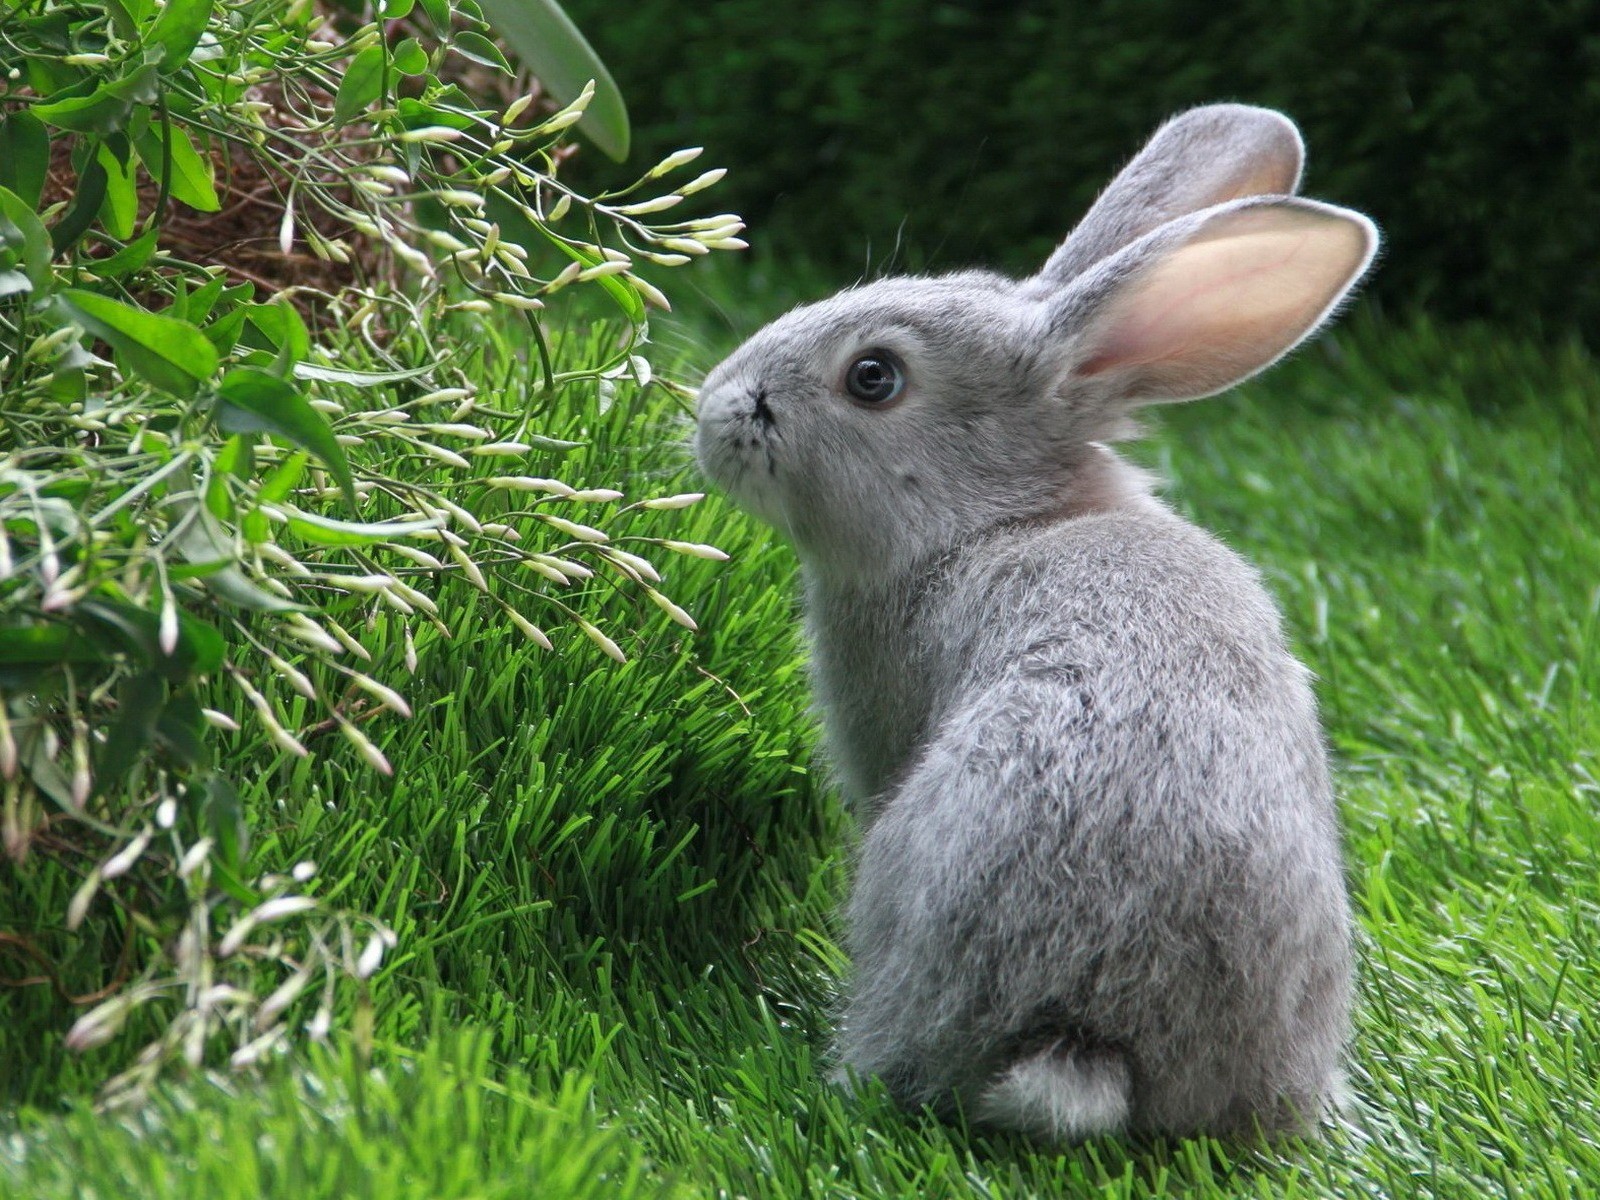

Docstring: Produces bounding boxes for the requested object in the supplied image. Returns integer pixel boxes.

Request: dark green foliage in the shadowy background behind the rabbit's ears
[568,0,1600,334]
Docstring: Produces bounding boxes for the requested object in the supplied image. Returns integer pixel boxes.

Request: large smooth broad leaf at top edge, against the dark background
[470,0,630,162]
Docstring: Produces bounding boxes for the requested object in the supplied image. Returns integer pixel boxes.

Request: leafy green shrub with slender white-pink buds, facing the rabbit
[0,0,742,1093]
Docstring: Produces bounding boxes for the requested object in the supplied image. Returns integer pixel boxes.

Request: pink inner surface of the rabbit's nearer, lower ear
[1078,205,1371,400]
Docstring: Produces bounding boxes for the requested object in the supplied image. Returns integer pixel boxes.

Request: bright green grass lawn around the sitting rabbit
[0,294,1600,1198]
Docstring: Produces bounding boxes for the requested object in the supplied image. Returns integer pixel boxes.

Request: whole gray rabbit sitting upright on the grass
[696,104,1378,1139]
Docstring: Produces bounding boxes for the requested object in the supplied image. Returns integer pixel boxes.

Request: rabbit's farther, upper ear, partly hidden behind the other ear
[1037,104,1306,288]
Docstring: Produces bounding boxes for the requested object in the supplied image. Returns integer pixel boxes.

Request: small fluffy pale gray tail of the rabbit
[976,1043,1133,1142]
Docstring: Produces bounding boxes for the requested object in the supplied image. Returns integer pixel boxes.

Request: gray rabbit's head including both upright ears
[696,104,1378,574]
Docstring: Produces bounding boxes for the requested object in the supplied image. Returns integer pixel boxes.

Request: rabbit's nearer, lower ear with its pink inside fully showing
[1050,197,1378,403]
